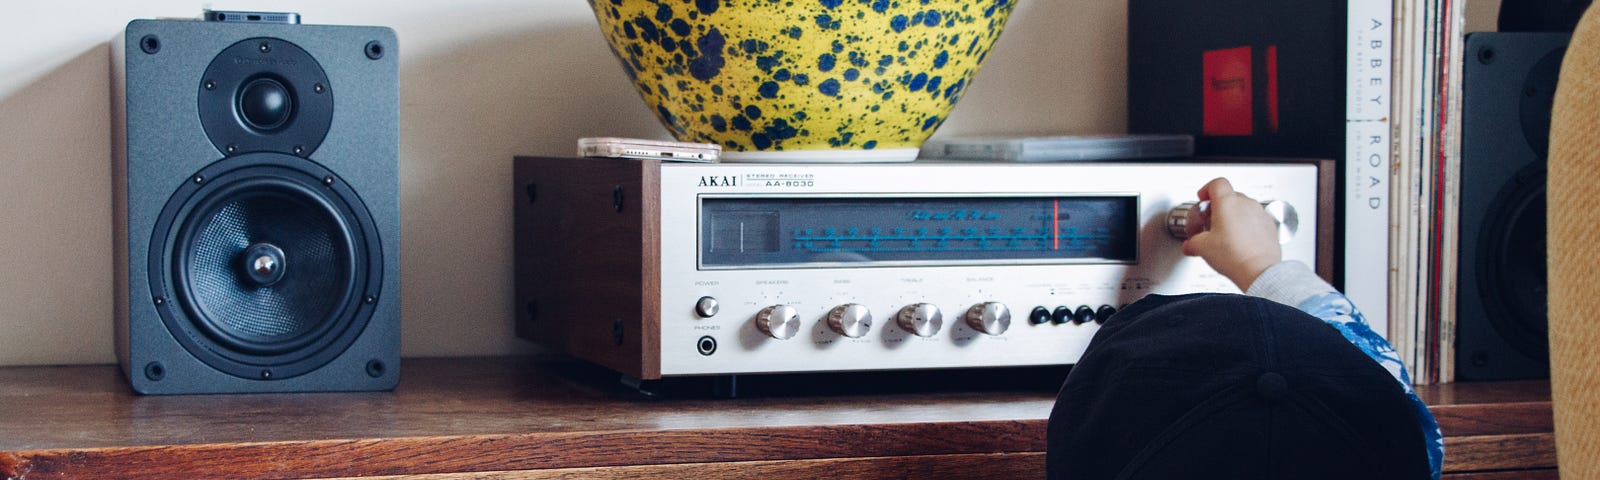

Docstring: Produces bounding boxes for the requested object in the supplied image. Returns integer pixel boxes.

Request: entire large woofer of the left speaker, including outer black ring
[149,154,382,379]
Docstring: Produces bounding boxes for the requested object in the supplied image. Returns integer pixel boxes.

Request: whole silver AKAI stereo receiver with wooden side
[515,157,1333,379]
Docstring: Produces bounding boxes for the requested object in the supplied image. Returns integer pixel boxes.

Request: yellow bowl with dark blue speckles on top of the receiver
[589,0,1014,162]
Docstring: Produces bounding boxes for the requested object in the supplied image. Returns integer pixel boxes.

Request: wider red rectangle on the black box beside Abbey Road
[1200,46,1254,136]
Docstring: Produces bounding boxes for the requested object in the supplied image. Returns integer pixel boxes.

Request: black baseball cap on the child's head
[1046,294,1430,478]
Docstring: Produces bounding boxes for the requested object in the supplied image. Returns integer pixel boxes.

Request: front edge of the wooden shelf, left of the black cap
[0,421,1045,478]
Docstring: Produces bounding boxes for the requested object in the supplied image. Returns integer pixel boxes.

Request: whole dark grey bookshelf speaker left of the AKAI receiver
[112,21,400,394]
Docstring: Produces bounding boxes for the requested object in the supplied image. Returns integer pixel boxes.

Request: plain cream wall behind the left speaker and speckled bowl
[0,0,1126,365]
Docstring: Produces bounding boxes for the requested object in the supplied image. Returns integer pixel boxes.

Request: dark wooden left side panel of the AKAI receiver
[514,157,661,379]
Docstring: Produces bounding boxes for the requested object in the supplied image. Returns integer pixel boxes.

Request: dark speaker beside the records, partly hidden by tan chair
[1456,32,1571,381]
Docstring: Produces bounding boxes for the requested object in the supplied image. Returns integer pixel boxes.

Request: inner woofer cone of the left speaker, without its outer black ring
[182,176,355,354]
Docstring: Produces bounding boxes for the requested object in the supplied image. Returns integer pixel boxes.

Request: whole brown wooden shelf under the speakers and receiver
[0,357,1555,478]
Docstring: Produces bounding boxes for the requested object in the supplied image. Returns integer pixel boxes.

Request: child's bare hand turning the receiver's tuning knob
[1184,178,1283,291]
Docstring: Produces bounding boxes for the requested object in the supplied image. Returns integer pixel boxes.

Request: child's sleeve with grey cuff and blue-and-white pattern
[1246,261,1445,480]
